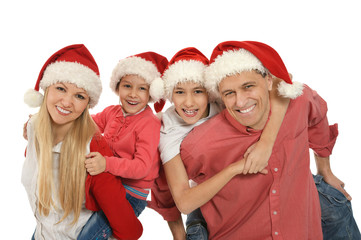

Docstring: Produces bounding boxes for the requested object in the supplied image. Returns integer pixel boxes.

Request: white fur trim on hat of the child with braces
[163,60,206,100]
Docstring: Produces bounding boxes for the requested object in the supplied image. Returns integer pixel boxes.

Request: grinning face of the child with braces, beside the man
[172,82,208,124]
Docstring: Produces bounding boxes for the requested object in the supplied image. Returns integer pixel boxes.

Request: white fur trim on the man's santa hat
[205,48,268,100]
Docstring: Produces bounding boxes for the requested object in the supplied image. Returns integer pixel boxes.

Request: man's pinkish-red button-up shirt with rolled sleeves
[181,86,338,240]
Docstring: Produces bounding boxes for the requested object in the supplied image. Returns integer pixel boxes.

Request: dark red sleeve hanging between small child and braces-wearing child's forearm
[147,166,181,222]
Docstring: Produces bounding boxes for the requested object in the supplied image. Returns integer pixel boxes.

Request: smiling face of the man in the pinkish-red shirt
[219,71,272,130]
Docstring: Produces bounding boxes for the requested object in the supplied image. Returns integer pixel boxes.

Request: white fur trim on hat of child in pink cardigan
[110,56,160,95]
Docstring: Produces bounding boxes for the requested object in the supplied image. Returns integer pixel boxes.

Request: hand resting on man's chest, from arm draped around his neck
[243,141,272,174]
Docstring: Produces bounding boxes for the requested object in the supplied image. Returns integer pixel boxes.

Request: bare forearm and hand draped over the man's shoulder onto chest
[243,78,290,174]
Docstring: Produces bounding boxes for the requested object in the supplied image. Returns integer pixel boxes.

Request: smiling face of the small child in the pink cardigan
[118,75,149,114]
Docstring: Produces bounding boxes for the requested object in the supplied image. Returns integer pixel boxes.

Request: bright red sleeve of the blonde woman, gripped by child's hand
[85,135,143,239]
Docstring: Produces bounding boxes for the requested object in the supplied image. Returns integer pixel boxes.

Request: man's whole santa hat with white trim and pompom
[205,41,303,99]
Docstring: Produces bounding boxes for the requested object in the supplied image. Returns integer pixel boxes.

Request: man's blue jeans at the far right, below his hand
[313,175,361,240]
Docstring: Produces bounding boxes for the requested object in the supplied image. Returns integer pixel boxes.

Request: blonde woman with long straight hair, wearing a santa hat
[22,44,142,240]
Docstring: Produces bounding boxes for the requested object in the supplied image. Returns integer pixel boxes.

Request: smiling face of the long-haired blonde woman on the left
[46,83,89,129]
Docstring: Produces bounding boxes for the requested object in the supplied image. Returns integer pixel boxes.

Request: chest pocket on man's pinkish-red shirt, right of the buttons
[283,128,310,175]
